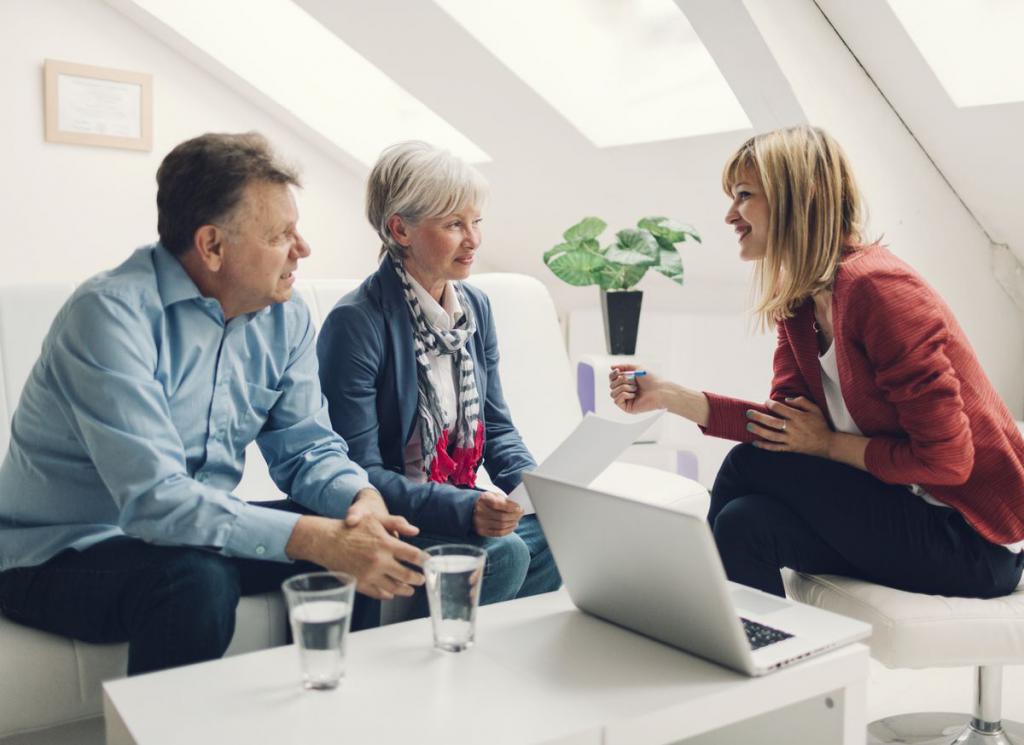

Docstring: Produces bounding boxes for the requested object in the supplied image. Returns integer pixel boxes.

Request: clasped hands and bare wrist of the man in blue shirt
[285,514,423,600]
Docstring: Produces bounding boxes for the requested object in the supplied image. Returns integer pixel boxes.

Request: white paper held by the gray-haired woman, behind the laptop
[508,409,665,515]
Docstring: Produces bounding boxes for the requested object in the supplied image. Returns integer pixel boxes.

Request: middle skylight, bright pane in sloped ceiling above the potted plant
[434,0,751,147]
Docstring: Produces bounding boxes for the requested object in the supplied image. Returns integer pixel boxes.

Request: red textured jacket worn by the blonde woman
[705,246,1024,543]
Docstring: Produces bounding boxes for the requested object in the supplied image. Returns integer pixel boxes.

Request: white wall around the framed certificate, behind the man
[0,0,378,282]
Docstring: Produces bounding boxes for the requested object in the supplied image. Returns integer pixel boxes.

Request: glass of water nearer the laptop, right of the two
[423,543,487,652]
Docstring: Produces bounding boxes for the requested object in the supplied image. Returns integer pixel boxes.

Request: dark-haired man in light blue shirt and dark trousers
[0,133,422,674]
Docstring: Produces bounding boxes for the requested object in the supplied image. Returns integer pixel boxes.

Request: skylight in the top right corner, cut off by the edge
[889,0,1024,106]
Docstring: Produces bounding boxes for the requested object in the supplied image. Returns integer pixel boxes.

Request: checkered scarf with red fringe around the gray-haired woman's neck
[388,257,483,486]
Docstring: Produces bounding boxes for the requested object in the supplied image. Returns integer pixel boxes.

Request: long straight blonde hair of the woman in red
[722,126,863,328]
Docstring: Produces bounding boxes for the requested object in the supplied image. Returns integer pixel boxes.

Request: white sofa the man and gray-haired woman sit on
[0,274,708,745]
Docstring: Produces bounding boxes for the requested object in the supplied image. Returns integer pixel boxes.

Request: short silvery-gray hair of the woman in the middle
[367,140,487,260]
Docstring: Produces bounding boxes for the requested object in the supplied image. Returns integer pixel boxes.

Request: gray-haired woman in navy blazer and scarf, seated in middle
[316,142,561,610]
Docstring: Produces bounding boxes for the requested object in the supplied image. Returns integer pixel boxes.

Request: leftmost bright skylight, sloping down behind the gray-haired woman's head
[121,0,490,166]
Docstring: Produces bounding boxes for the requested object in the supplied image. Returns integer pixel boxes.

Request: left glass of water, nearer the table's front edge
[282,572,355,690]
